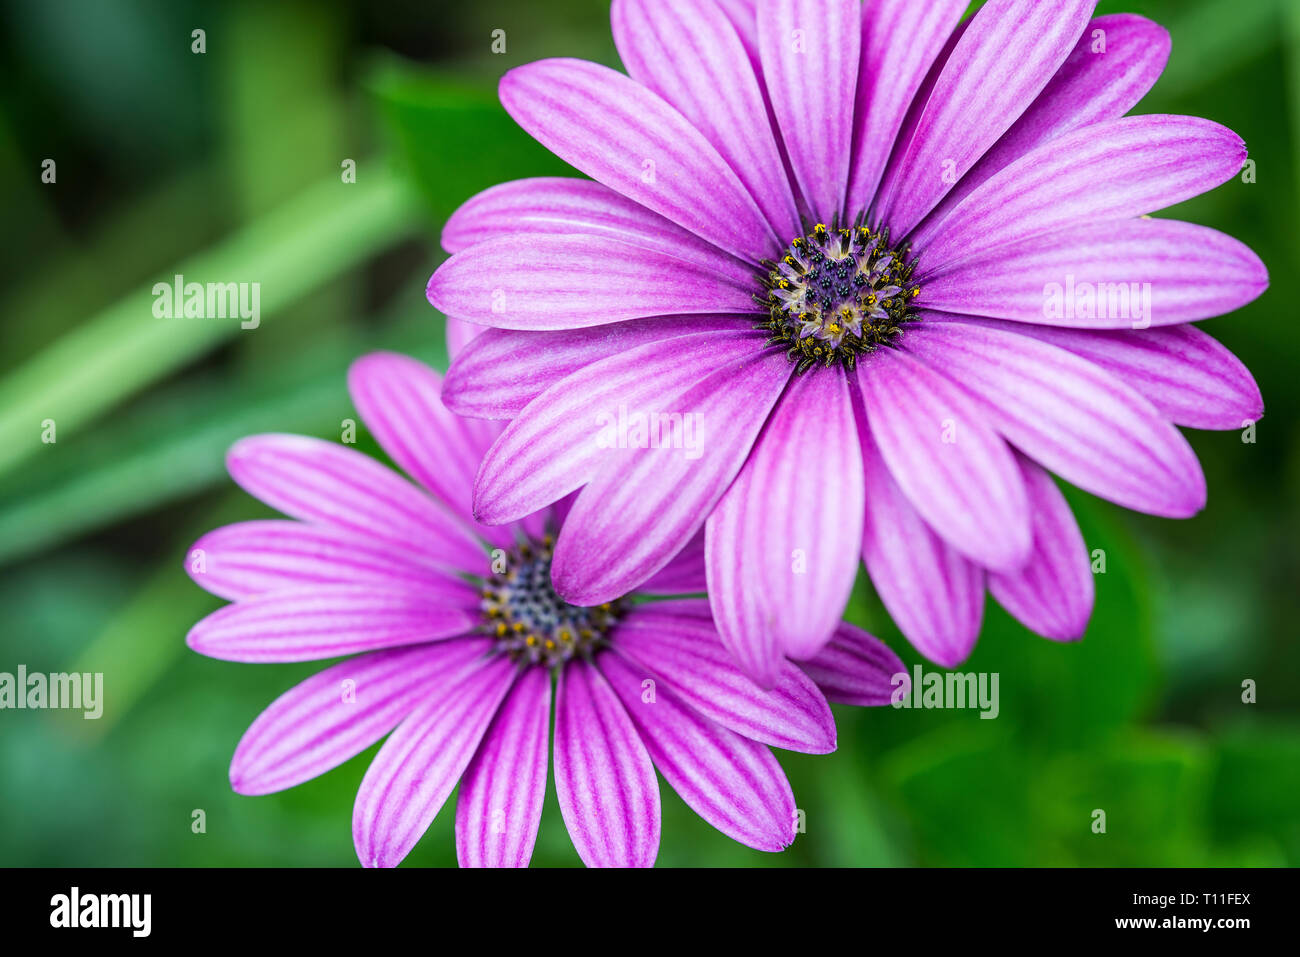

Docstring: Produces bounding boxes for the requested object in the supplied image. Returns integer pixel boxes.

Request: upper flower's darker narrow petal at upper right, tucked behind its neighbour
[930,13,1170,231]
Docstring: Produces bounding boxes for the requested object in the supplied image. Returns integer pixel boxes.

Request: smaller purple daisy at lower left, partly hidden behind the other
[187,340,902,866]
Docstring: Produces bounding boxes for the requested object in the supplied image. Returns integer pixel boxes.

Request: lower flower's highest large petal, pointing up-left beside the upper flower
[347,352,511,546]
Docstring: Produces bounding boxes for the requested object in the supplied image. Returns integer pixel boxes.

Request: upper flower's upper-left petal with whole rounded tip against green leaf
[499,60,780,261]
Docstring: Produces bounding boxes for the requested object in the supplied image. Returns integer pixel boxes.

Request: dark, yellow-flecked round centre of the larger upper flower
[754,224,920,373]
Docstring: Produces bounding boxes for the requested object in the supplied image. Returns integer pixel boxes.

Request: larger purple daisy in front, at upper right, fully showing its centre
[428,0,1268,685]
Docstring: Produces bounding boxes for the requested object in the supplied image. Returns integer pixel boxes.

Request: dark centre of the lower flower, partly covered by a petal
[480,536,625,667]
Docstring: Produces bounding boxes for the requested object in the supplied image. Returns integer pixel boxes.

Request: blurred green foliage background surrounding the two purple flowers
[0,0,1300,866]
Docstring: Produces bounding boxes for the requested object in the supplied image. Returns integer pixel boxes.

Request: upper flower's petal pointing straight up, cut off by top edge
[758,0,862,221]
